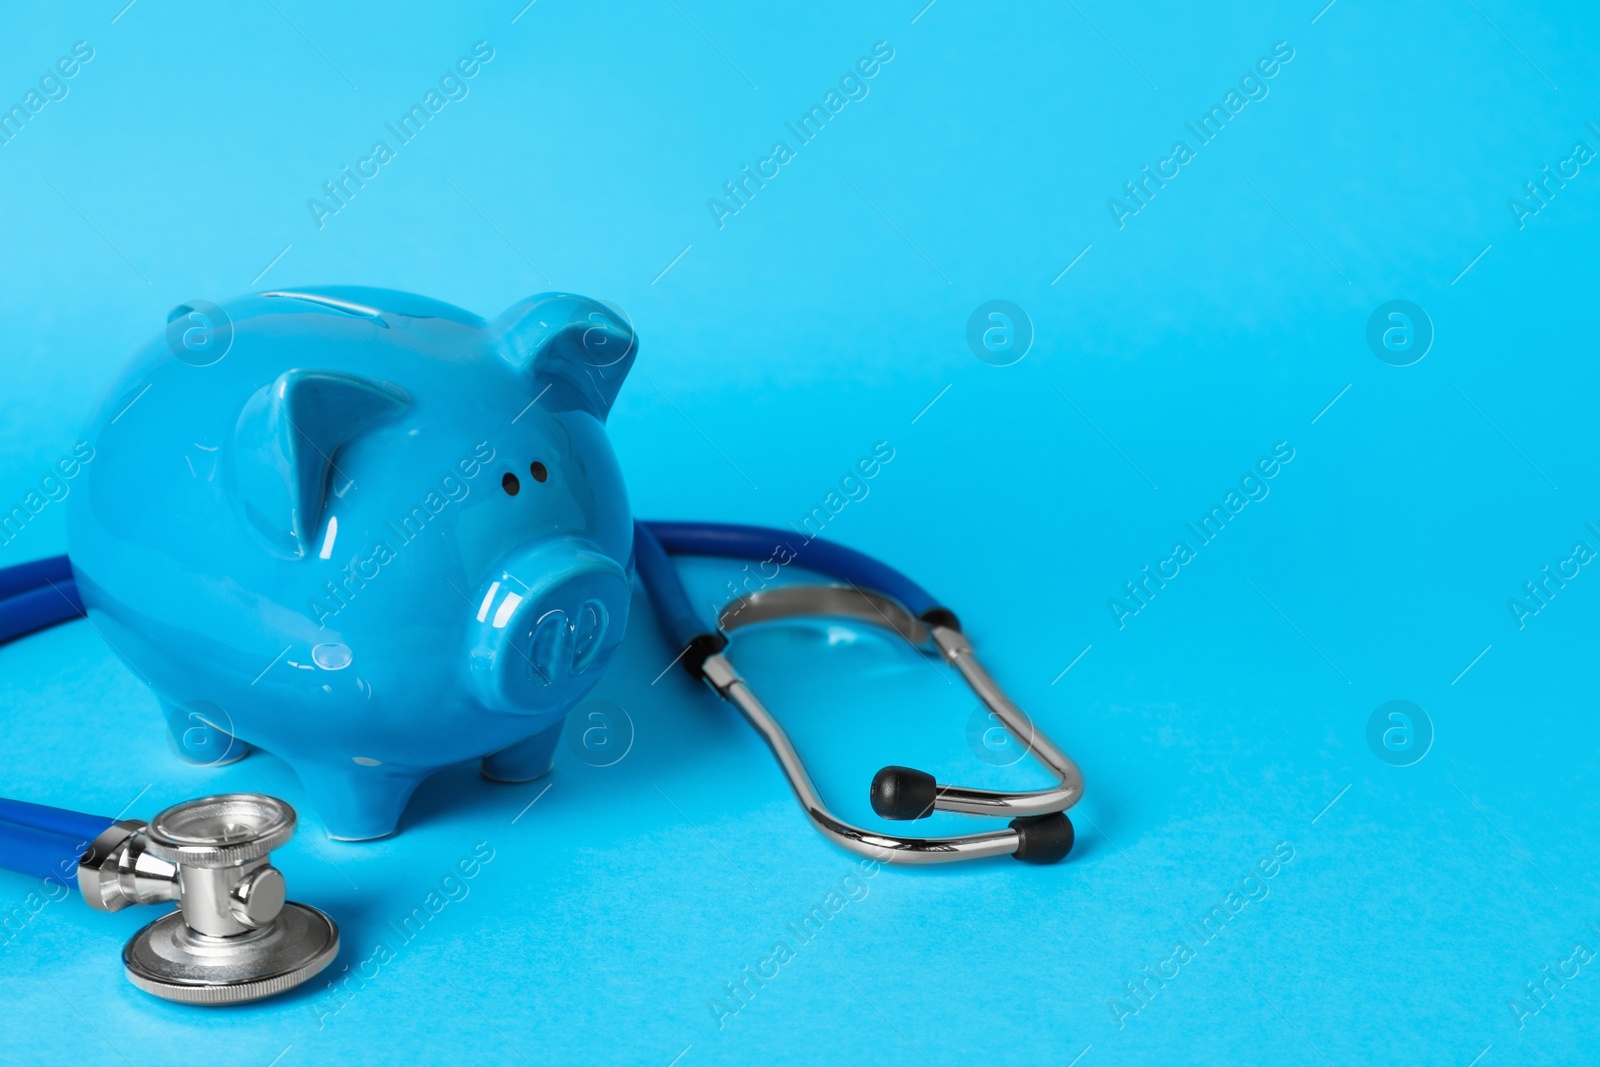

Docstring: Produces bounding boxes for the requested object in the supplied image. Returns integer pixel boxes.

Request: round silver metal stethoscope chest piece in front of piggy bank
[78,793,339,1005]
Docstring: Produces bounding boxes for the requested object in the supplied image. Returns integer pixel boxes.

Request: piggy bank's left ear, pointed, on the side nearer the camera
[230,370,410,558]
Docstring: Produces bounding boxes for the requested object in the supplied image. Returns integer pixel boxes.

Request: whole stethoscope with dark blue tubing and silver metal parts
[0,522,1083,1005]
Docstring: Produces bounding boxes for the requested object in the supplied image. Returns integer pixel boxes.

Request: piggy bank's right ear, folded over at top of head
[491,293,638,422]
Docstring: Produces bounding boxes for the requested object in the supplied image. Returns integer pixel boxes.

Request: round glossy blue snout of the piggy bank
[469,539,629,712]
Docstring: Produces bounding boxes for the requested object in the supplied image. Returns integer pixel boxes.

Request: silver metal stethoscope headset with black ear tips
[686,585,1083,864]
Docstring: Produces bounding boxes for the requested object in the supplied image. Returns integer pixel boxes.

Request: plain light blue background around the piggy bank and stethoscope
[0,0,1600,1067]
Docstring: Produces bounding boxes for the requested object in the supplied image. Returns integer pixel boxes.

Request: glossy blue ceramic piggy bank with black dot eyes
[69,288,635,840]
